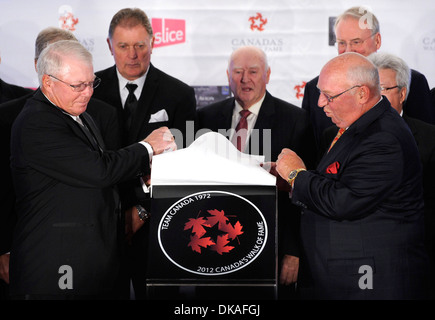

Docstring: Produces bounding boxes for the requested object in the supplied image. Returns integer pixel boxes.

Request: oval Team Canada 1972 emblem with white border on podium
[158,191,268,276]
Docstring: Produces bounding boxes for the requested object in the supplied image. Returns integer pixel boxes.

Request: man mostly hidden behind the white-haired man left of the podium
[0,27,121,299]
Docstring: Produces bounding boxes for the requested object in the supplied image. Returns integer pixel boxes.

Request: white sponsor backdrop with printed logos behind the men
[0,0,435,106]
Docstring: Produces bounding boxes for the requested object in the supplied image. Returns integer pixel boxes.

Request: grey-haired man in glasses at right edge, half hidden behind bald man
[368,53,435,299]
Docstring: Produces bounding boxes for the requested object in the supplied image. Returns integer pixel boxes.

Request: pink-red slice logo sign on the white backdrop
[151,18,186,48]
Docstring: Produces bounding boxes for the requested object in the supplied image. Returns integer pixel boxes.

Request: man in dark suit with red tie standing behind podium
[195,46,315,298]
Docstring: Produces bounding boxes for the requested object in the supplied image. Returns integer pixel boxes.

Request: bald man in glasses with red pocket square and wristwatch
[277,53,427,299]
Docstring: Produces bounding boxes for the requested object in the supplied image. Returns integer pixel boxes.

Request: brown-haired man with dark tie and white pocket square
[94,8,196,299]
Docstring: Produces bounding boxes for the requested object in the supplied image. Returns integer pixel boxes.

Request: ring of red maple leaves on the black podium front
[184,209,243,255]
